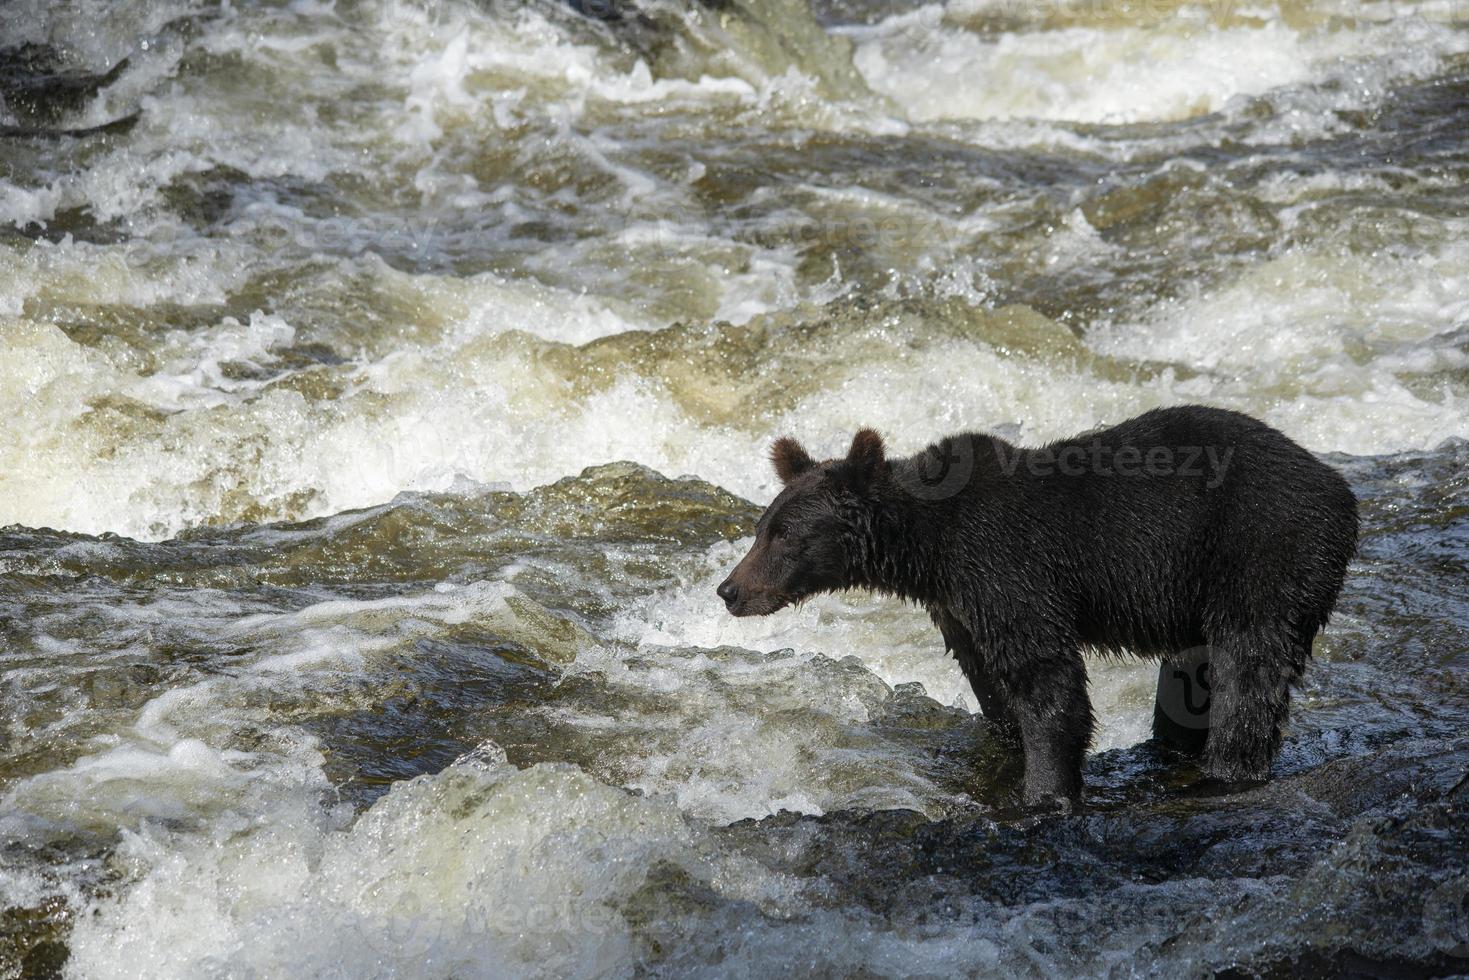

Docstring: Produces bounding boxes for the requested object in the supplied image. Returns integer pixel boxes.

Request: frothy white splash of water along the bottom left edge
[68,751,789,980]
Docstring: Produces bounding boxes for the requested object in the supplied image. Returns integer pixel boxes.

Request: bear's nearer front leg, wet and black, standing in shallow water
[1005,649,1093,807]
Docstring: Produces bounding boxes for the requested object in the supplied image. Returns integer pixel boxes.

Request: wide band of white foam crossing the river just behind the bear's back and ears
[0,246,1466,538]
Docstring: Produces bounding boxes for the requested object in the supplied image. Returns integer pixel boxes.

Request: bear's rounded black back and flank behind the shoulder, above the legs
[949,406,1357,654]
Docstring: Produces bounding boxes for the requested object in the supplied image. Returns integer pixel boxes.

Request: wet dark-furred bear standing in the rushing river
[720,406,1357,802]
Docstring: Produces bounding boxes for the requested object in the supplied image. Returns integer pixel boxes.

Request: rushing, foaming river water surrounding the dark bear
[0,0,1469,979]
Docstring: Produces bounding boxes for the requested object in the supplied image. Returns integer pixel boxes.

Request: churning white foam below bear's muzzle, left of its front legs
[555,645,964,823]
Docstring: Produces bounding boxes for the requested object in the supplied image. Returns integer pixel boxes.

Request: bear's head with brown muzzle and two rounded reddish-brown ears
[718,429,887,616]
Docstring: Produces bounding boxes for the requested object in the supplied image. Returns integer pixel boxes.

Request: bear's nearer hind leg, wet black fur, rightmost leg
[1205,630,1310,783]
